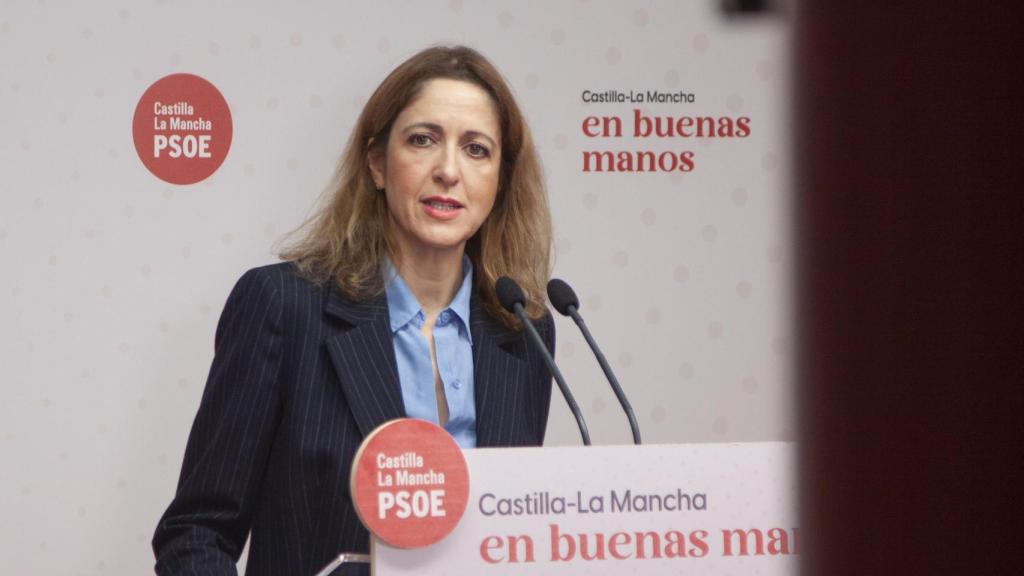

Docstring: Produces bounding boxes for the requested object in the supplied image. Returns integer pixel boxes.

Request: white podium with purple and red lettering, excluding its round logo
[317,420,800,576]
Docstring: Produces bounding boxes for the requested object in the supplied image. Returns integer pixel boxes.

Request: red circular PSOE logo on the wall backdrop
[132,74,231,184]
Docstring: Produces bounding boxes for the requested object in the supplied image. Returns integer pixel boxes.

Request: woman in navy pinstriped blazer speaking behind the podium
[153,47,554,574]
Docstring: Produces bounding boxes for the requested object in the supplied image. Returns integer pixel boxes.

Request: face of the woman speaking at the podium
[370,79,502,255]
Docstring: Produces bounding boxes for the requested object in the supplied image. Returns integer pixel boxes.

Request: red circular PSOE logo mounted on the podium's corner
[351,418,469,548]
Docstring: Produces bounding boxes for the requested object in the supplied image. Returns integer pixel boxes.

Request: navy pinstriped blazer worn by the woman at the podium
[153,262,555,576]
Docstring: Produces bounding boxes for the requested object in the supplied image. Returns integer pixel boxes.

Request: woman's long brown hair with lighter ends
[281,46,551,329]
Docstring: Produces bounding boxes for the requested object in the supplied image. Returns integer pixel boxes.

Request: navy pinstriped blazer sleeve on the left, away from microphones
[153,269,283,575]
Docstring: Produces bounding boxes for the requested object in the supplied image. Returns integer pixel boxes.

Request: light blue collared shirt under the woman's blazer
[384,256,476,448]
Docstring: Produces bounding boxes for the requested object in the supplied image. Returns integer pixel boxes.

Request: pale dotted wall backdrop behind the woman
[0,0,794,574]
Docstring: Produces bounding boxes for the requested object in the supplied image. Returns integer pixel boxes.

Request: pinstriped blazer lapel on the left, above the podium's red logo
[326,288,406,436]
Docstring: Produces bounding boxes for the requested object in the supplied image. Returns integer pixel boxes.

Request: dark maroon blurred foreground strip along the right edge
[794,1,1024,576]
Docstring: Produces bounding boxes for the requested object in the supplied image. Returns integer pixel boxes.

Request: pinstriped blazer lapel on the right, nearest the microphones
[469,293,525,448]
